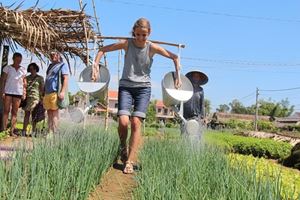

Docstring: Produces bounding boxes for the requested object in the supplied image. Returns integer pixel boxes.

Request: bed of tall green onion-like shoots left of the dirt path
[0,124,119,200]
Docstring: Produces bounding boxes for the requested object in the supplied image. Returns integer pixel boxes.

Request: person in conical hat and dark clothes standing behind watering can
[183,71,208,120]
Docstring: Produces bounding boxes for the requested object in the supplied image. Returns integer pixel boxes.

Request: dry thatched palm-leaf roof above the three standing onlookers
[0,5,95,67]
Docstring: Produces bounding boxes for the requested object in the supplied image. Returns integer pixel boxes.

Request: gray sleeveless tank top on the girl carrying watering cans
[120,39,153,87]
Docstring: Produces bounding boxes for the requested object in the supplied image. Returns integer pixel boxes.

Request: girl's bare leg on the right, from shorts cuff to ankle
[128,117,142,161]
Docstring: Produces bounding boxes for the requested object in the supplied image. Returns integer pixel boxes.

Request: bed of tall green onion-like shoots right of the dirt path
[133,139,294,200]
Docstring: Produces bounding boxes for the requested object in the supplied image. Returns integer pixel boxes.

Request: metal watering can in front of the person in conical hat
[161,72,201,139]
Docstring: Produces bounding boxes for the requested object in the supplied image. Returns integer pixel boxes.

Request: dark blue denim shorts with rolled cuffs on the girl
[118,87,151,118]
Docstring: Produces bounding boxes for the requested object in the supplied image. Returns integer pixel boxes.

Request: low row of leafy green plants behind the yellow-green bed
[205,131,292,159]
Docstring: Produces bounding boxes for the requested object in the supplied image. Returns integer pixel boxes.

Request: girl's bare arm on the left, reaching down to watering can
[92,40,128,81]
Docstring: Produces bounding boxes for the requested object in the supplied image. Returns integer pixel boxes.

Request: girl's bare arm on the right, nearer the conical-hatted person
[151,43,181,88]
